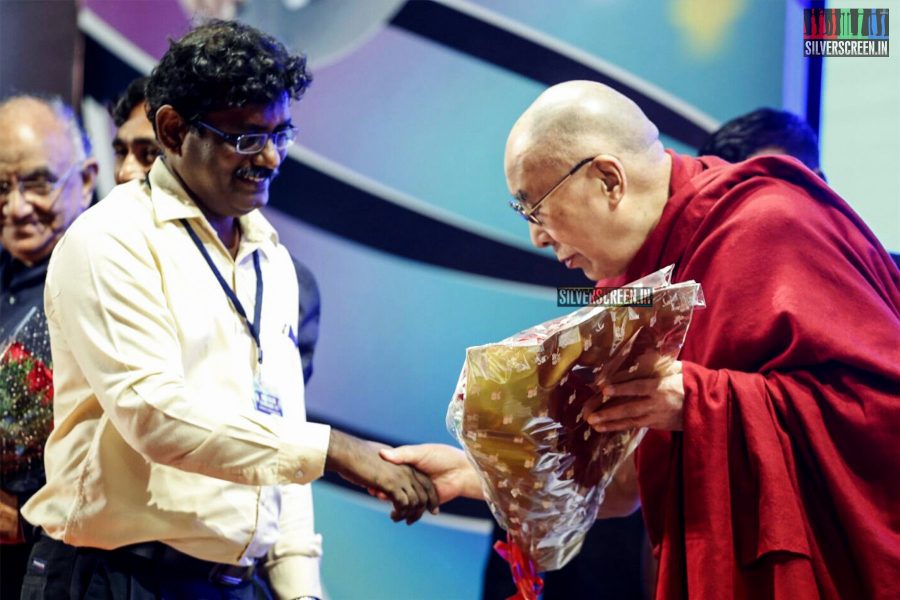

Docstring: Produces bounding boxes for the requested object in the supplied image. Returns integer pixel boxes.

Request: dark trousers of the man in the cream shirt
[21,535,271,600]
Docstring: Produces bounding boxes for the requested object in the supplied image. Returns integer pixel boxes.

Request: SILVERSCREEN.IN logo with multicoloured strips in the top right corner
[803,8,890,56]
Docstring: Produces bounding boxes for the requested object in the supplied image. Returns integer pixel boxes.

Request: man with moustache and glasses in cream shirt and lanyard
[22,21,437,600]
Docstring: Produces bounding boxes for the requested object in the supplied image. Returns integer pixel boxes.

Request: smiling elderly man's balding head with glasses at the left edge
[0,96,97,264]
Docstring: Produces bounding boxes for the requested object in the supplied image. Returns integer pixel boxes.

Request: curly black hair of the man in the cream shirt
[146,20,312,129]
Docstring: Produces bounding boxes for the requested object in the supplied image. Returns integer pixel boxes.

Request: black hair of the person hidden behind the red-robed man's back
[697,108,819,171]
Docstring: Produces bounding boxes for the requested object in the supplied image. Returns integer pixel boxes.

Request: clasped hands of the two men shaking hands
[325,429,481,525]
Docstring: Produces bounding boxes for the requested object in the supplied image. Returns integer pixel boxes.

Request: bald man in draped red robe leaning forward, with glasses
[384,82,900,600]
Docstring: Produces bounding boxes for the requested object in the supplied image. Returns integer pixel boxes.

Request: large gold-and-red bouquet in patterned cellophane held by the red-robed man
[447,267,704,598]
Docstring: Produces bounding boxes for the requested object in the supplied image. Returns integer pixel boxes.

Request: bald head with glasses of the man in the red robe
[504,81,671,280]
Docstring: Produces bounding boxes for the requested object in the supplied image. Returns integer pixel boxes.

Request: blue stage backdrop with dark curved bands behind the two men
[79,0,805,600]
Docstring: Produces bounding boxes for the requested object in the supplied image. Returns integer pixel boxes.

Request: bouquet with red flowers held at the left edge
[0,308,53,492]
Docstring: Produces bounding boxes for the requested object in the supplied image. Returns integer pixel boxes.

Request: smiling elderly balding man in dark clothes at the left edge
[0,96,97,598]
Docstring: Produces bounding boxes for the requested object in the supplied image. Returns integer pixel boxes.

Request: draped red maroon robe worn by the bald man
[603,153,900,600]
